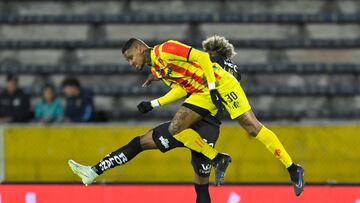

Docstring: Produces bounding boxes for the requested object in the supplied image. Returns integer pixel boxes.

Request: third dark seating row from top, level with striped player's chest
[0,63,360,75]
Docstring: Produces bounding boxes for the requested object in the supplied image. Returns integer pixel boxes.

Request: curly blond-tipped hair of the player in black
[202,35,236,58]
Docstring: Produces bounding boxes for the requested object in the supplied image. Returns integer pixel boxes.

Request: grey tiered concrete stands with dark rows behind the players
[0,0,360,120]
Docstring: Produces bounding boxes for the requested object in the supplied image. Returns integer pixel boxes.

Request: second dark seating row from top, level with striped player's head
[0,39,360,50]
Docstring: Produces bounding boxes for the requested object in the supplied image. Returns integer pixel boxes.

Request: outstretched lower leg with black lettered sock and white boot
[68,130,157,185]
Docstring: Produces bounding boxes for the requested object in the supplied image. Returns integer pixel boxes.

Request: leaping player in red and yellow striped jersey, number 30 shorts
[122,38,304,196]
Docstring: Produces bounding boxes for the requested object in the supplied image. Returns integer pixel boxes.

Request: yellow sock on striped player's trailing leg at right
[256,126,293,168]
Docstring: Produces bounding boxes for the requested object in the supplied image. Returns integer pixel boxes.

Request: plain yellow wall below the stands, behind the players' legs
[4,125,360,183]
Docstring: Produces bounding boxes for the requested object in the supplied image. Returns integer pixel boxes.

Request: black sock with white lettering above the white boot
[92,137,142,175]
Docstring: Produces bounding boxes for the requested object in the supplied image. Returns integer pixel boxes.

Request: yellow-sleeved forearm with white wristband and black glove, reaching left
[137,84,187,113]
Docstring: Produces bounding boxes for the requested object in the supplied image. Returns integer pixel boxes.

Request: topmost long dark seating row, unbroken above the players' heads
[0,13,360,25]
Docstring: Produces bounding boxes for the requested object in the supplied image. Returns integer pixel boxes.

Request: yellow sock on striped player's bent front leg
[174,128,218,160]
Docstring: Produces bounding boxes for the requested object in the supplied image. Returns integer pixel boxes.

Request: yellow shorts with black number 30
[184,74,251,119]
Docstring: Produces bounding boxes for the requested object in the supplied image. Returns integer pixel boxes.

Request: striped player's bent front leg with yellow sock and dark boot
[169,104,231,185]
